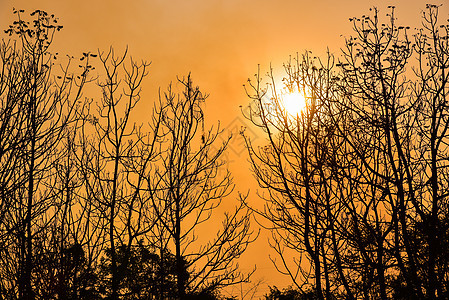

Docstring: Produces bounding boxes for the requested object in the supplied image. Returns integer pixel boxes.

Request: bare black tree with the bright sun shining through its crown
[244,53,338,299]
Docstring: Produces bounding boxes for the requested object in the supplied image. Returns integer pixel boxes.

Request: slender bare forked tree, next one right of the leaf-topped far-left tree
[79,48,160,299]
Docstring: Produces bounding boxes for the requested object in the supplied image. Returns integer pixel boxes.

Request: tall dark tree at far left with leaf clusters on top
[0,10,90,299]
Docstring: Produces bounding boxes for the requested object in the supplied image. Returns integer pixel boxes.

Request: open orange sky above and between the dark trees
[0,0,449,296]
